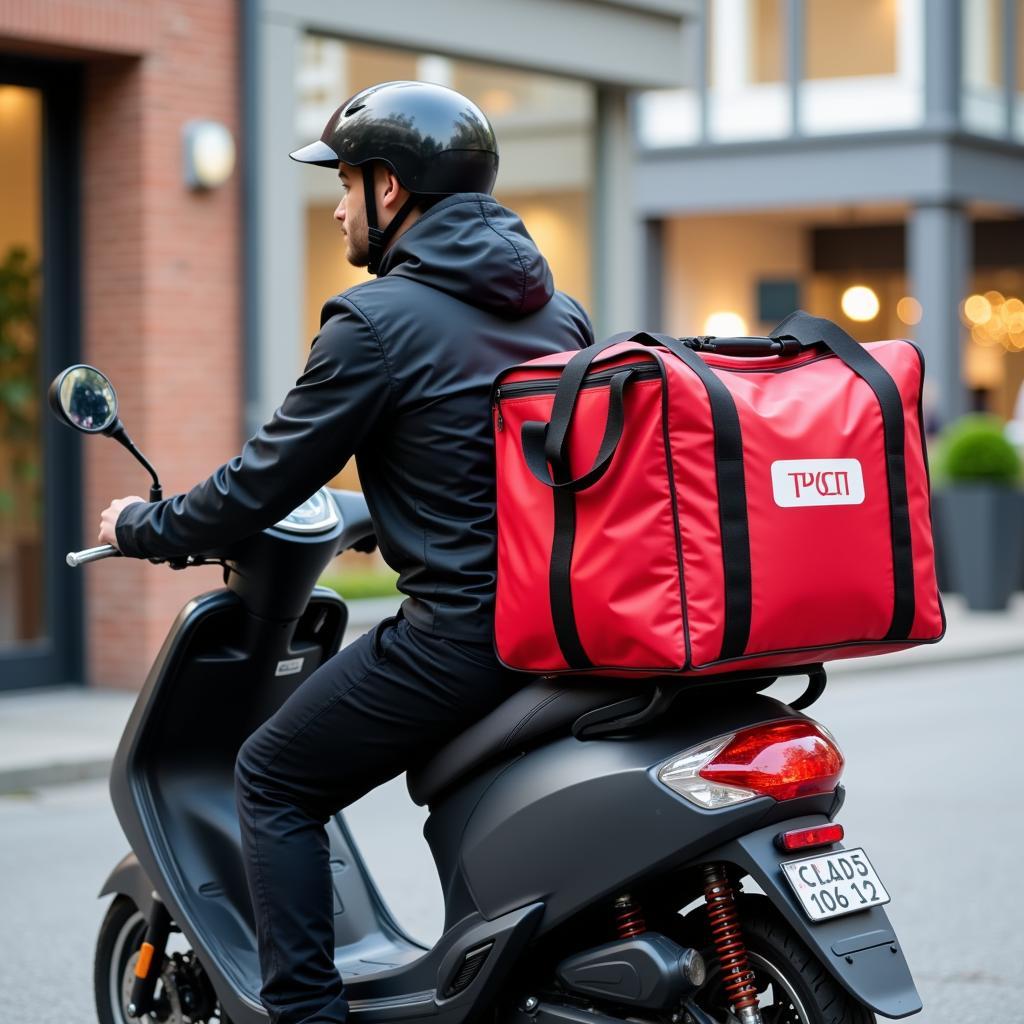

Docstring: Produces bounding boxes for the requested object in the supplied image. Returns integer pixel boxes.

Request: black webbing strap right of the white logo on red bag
[771,309,914,640]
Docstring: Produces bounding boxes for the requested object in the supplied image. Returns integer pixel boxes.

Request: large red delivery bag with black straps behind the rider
[494,311,945,676]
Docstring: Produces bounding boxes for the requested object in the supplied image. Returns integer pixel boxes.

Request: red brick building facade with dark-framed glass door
[0,0,244,689]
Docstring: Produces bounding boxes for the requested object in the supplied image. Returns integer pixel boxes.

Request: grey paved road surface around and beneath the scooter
[0,658,1024,1024]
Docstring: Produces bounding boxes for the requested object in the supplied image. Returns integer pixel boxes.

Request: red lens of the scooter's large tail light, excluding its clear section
[697,718,844,800]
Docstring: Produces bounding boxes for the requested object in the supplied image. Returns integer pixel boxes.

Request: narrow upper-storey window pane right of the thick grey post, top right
[961,0,1007,135]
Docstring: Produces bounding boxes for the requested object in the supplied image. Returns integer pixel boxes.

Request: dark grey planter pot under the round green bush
[933,483,1024,611]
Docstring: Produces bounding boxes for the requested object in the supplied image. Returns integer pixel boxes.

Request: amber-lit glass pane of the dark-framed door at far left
[0,85,46,648]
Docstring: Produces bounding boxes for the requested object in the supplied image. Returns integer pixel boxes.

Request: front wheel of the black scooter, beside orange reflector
[93,896,230,1024]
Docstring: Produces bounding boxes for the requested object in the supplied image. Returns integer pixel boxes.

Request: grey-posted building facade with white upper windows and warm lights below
[634,0,1024,422]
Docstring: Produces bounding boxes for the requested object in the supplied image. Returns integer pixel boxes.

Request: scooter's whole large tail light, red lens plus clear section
[657,718,844,808]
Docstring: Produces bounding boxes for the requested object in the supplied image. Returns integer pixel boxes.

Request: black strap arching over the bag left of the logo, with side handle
[521,332,752,669]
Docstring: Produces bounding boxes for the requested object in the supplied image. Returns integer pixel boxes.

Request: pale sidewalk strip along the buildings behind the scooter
[0,594,1024,794]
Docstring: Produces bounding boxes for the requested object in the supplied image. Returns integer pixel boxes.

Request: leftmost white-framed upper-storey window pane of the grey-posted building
[708,0,791,142]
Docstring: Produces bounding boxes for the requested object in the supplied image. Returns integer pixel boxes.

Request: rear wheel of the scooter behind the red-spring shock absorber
[686,896,874,1024]
